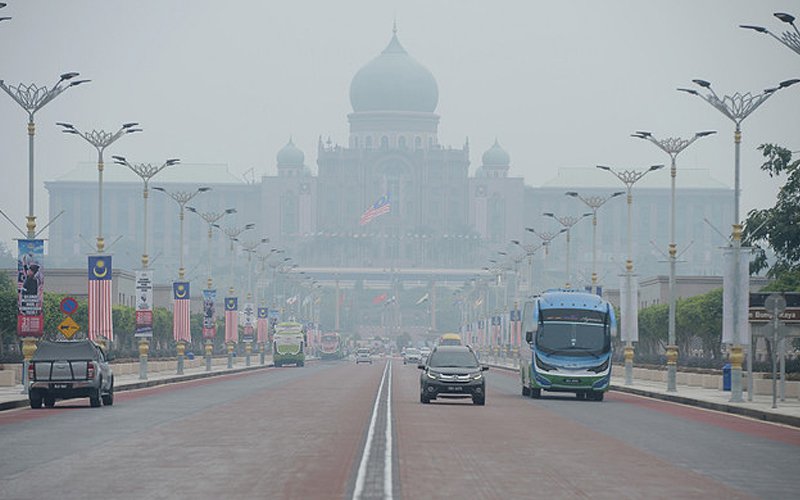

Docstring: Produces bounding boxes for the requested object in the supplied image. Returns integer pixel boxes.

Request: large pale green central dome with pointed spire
[350,32,439,113]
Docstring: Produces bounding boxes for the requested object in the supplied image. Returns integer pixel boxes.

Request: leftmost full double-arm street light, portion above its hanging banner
[0,72,89,239]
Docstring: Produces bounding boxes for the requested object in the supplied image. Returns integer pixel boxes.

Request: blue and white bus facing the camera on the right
[519,290,617,401]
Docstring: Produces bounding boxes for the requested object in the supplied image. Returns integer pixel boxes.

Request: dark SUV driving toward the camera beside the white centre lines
[419,345,489,406]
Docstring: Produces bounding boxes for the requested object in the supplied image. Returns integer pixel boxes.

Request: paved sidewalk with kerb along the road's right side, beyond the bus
[490,359,800,427]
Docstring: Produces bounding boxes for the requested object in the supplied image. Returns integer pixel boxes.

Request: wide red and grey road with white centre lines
[0,359,800,499]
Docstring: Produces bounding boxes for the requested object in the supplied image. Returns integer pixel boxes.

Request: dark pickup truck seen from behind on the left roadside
[28,340,114,408]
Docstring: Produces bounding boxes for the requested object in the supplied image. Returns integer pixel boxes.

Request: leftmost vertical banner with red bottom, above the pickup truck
[17,240,44,337]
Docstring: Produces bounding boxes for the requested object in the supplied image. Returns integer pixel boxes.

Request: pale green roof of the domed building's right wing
[539,167,731,189]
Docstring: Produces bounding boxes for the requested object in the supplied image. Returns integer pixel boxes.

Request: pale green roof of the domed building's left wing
[50,161,244,185]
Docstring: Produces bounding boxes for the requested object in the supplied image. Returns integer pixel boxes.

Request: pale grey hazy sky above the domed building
[0,0,800,254]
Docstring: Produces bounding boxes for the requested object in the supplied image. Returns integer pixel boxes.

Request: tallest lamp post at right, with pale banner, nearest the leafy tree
[678,79,800,402]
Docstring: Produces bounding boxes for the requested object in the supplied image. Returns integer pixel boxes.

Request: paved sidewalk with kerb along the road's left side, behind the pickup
[0,353,272,411]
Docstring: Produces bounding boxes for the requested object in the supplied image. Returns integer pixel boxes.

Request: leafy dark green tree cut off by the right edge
[743,144,800,291]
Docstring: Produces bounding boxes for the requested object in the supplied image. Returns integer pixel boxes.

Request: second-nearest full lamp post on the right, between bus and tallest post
[633,130,716,392]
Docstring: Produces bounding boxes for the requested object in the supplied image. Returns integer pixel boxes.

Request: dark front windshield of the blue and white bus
[536,322,611,356]
